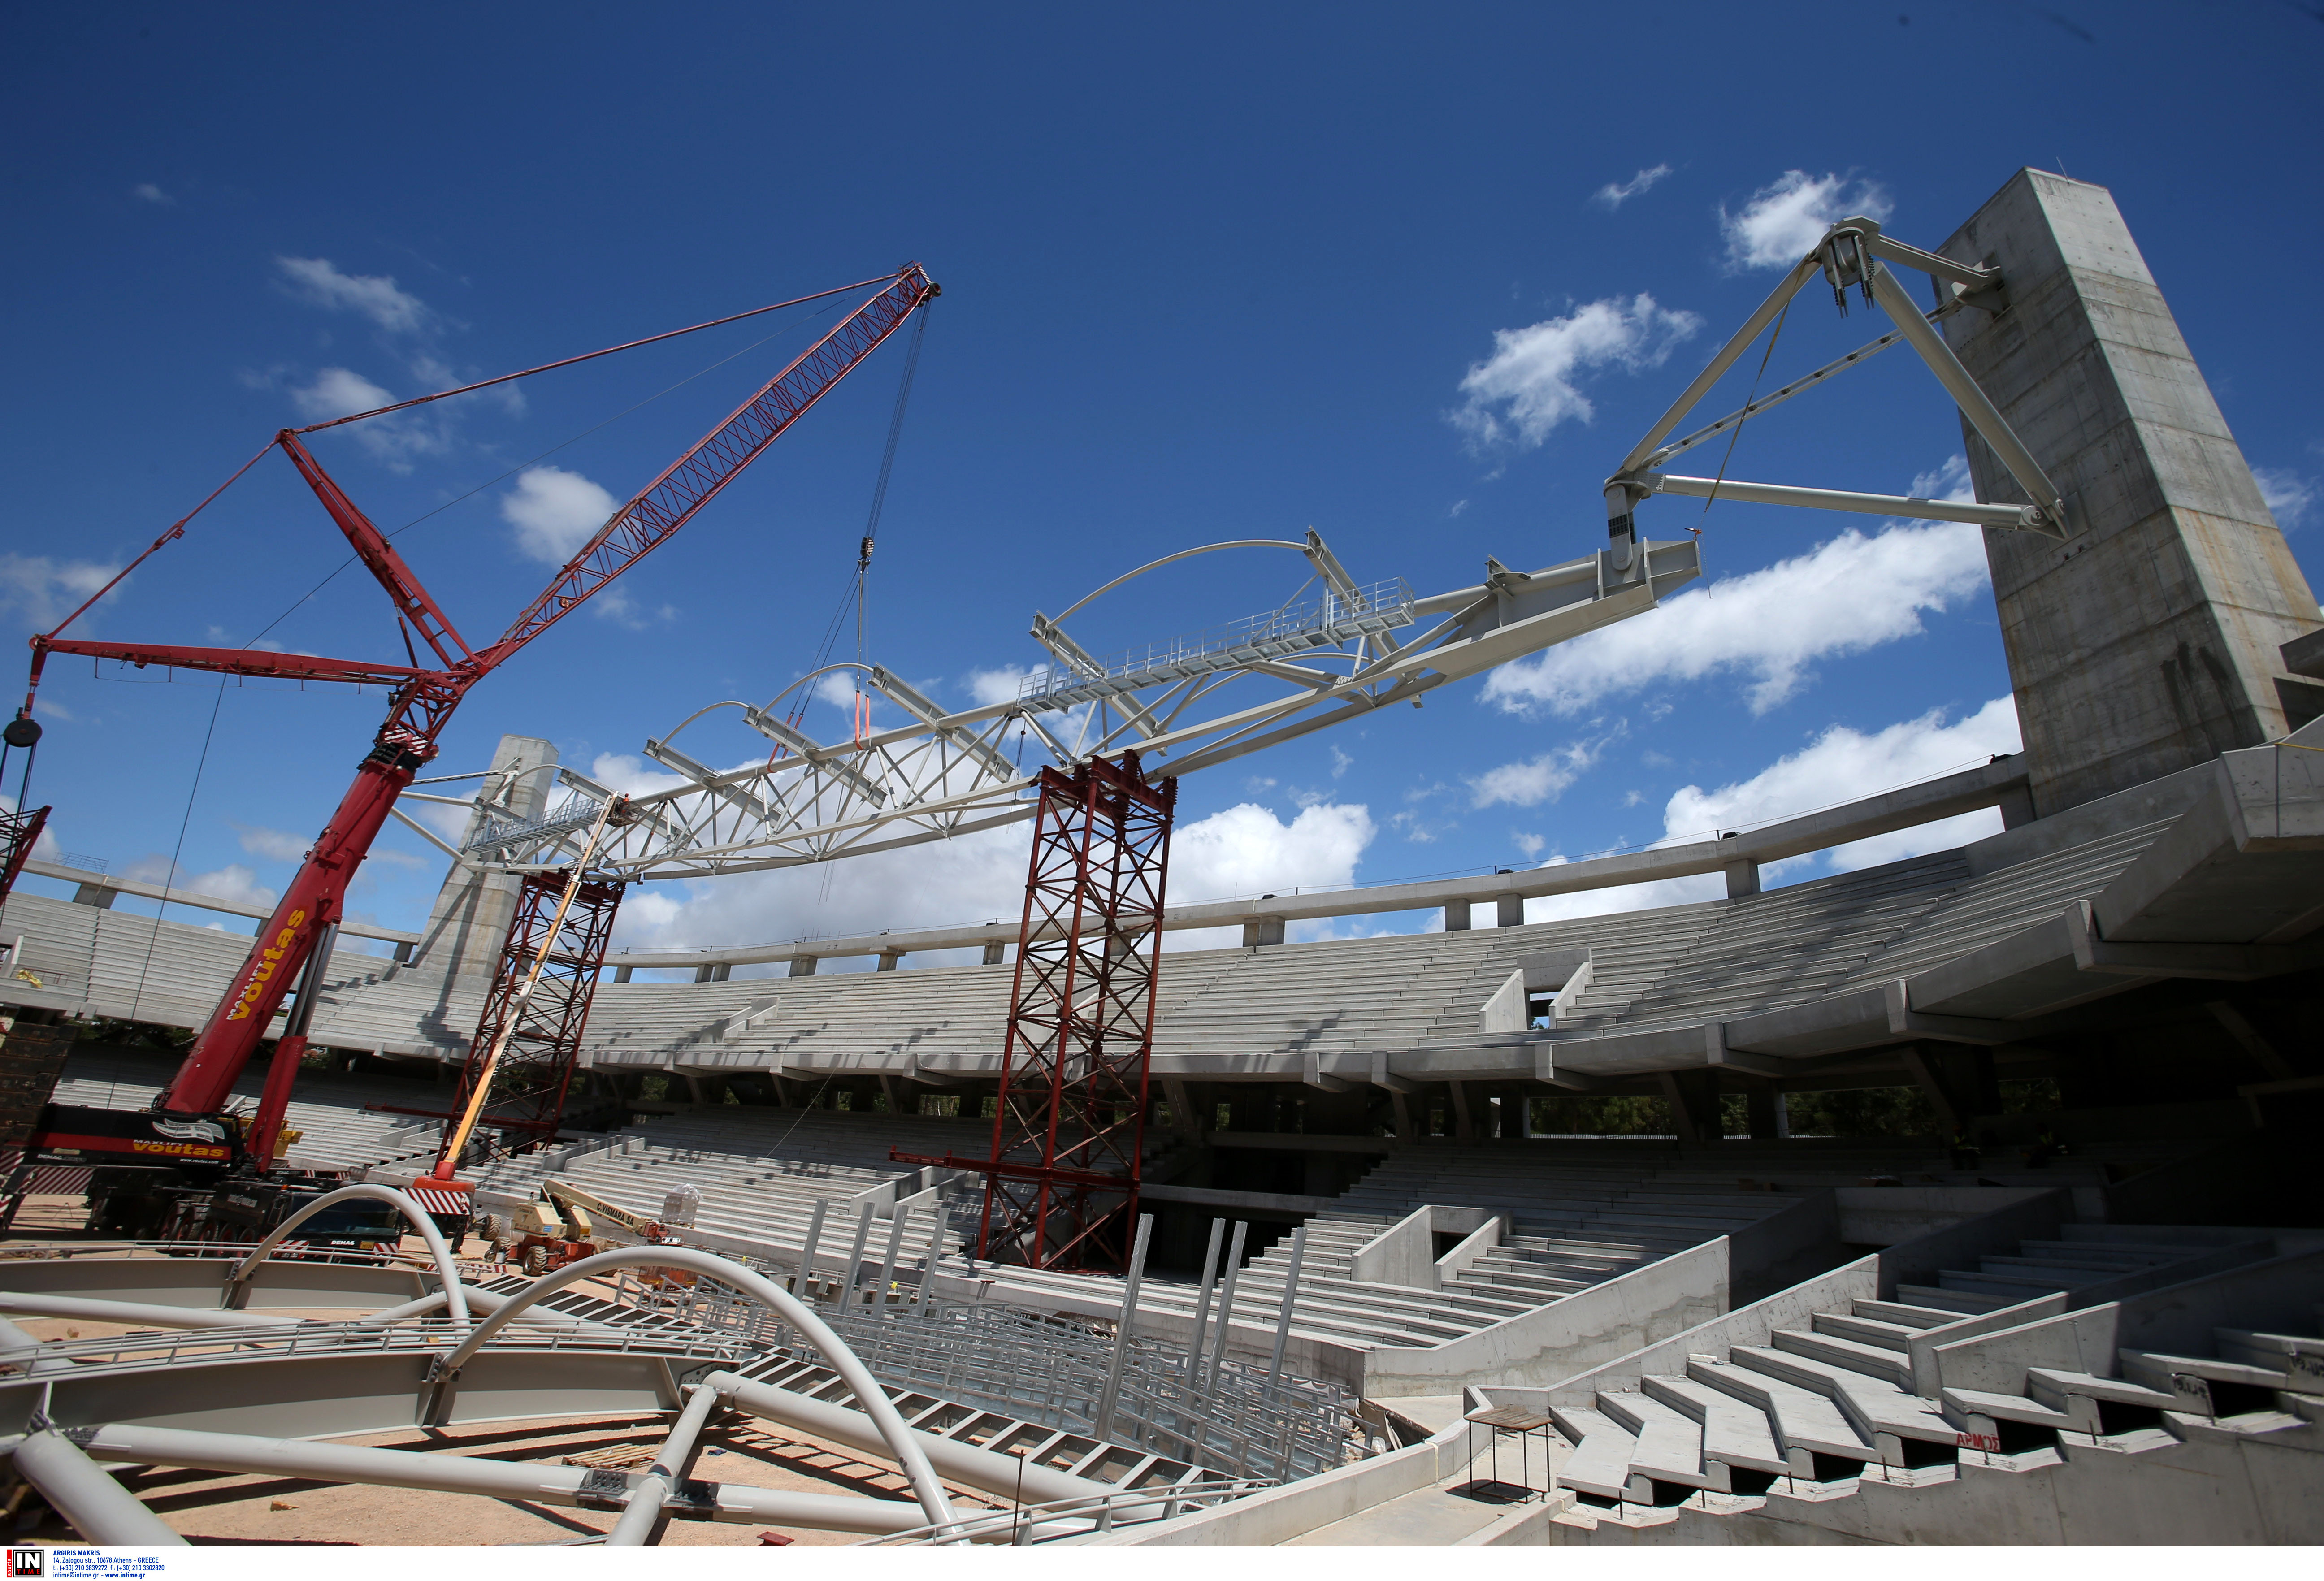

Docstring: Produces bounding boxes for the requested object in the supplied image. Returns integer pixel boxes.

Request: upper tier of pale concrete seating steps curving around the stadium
[0,809,2161,1079]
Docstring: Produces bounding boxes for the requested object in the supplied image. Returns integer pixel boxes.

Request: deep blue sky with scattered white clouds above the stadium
[0,0,2324,976]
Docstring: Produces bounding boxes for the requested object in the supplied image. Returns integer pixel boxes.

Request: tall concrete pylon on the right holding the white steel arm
[1938,170,2320,816]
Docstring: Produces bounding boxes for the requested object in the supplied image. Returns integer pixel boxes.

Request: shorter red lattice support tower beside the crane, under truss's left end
[446,872,623,1162]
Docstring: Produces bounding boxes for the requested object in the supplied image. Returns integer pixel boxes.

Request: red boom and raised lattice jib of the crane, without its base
[26,263,939,1116]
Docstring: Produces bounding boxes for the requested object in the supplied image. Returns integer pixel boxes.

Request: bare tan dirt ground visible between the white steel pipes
[0,1197,1004,1548]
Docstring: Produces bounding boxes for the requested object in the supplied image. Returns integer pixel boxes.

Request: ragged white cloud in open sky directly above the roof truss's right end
[1450,290,1704,446]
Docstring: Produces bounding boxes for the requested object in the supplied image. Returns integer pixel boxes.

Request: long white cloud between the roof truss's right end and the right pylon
[1485,521,1987,714]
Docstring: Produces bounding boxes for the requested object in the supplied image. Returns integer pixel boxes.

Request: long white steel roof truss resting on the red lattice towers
[437,530,1701,879]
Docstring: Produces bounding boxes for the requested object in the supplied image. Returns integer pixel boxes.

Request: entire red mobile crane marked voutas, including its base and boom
[18,263,939,1200]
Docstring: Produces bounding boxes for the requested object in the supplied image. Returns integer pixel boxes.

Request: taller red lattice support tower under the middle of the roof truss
[976,751,1178,1267]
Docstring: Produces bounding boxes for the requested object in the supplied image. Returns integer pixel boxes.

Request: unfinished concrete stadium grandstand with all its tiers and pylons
[0,172,2324,1546]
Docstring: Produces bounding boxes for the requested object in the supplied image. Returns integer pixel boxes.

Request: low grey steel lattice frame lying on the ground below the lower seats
[665,1279,1355,1481]
